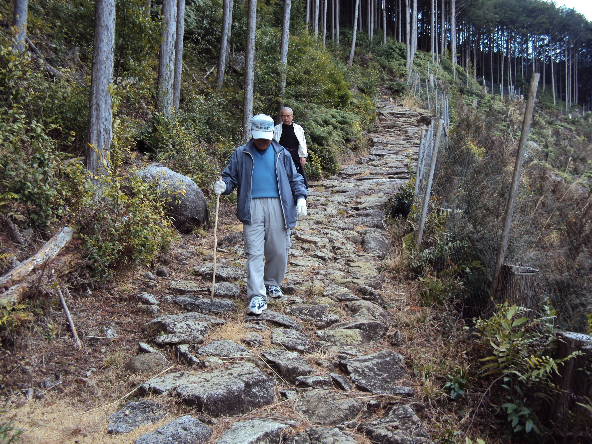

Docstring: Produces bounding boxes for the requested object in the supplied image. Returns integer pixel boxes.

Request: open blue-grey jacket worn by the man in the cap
[222,140,307,229]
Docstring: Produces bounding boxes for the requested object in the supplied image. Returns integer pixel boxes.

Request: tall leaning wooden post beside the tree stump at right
[491,72,540,299]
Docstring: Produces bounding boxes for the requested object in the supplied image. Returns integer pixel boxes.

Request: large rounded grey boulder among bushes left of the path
[138,164,209,233]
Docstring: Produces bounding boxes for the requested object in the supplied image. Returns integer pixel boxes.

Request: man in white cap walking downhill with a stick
[213,114,307,315]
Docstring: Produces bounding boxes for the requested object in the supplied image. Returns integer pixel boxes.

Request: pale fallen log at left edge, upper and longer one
[0,227,74,292]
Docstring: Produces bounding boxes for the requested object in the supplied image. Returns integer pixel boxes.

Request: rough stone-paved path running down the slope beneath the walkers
[109,100,431,444]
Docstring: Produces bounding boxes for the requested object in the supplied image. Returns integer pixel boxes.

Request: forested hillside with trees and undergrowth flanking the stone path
[0,0,592,443]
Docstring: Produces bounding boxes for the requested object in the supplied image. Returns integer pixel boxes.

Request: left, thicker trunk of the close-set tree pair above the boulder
[158,0,177,116]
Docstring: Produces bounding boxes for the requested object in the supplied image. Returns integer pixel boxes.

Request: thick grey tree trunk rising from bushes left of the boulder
[86,0,115,176]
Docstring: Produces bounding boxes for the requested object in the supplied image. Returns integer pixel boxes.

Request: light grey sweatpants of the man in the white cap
[243,198,290,297]
